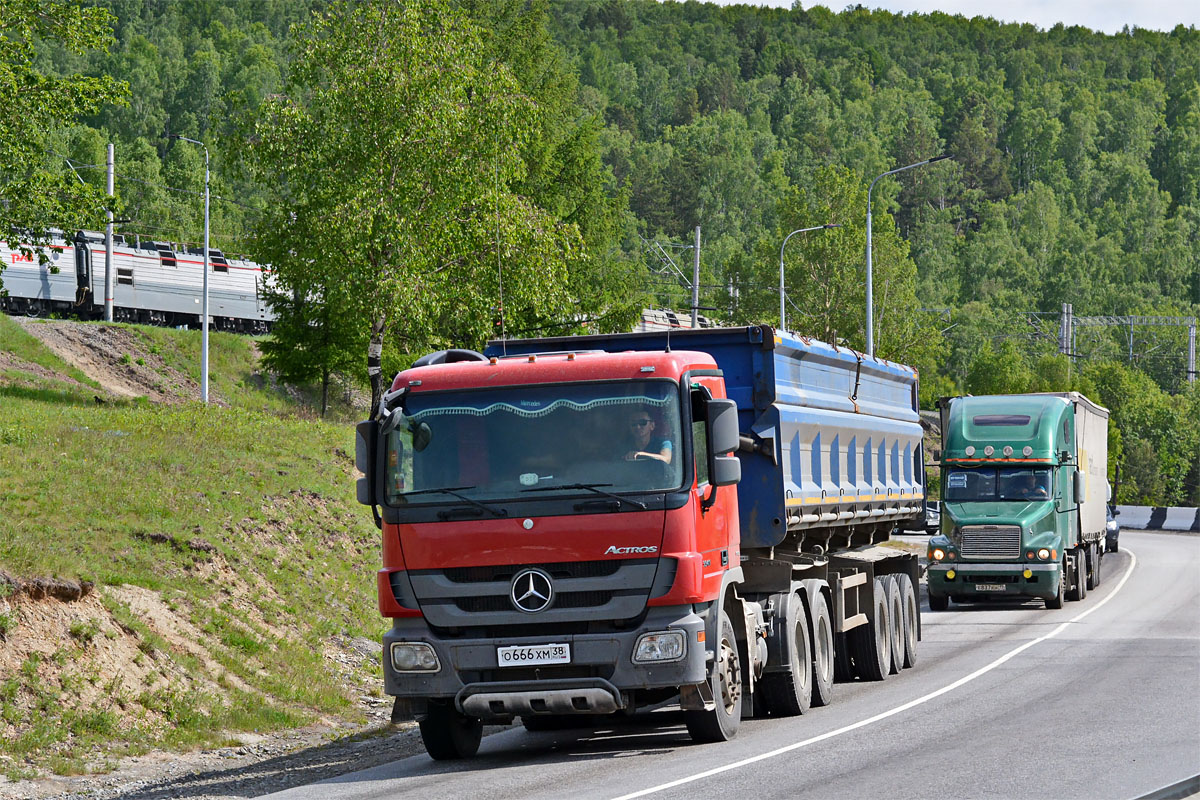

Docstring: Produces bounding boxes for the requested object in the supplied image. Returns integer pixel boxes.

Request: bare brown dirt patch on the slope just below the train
[13,317,216,405]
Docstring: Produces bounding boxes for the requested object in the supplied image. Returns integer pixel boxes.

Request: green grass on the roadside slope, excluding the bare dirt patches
[0,315,384,775]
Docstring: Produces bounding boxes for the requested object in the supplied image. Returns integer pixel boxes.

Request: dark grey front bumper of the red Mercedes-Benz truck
[383,606,708,718]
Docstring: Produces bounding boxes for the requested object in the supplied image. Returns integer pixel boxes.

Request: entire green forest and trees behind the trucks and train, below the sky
[7,0,1200,505]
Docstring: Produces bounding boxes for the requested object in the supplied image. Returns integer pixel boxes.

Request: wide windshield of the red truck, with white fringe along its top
[385,380,683,505]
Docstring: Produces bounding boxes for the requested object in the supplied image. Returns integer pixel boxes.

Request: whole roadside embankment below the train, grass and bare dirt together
[0,315,383,777]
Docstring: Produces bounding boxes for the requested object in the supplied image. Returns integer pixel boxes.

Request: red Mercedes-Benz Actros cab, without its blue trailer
[358,350,742,758]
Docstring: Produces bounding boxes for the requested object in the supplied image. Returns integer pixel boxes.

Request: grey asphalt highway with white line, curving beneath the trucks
[270,530,1200,800]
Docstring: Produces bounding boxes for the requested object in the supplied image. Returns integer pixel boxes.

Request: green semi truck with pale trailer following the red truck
[926,392,1109,610]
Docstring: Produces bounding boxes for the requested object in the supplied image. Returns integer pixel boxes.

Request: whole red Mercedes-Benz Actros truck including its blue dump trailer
[356,326,924,759]
